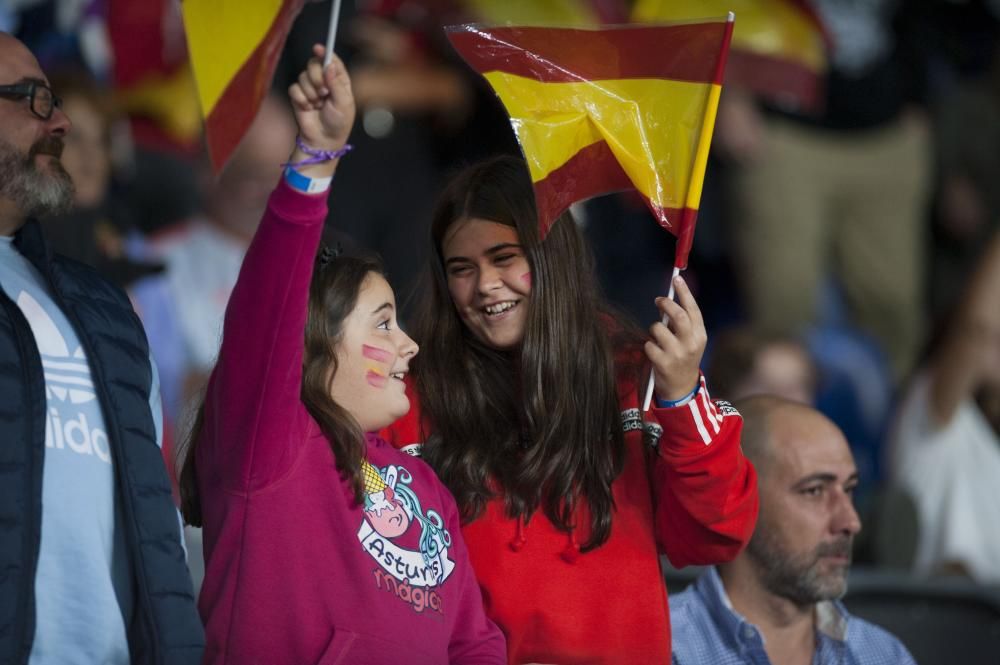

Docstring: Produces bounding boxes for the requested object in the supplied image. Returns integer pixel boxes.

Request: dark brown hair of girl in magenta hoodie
[179,249,385,526]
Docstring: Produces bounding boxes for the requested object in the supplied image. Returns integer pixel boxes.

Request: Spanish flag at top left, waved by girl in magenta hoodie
[181,0,305,172]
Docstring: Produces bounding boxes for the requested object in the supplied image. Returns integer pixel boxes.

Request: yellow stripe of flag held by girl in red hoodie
[485,72,719,208]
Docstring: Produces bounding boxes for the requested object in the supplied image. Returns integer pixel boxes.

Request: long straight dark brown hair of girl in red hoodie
[415,157,641,550]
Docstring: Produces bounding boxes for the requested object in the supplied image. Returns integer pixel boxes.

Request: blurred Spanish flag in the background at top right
[632,0,827,111]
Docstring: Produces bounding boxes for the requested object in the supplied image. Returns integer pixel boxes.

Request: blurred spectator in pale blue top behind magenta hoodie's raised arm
[131,96,296,436]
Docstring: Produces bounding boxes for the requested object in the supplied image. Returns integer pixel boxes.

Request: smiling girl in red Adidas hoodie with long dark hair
[387,158,757,665]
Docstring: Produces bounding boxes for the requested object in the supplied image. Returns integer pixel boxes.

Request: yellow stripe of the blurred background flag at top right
[632,0,826,71]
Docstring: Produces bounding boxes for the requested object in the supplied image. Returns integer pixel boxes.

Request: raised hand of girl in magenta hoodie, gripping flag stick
[288,44,355,161]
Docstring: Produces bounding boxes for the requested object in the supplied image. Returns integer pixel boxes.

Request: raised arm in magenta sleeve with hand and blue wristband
[201,47,354,491]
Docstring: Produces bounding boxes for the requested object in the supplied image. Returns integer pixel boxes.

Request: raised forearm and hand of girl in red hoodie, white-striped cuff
[646,278,758,567]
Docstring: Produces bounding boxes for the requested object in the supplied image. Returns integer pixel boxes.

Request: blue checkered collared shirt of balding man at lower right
[670,568,915,665]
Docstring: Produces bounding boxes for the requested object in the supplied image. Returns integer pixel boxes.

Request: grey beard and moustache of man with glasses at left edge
[0,136,73,217]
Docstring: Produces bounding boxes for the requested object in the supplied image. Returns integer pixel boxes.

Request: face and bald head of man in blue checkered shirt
[747,406,861,605]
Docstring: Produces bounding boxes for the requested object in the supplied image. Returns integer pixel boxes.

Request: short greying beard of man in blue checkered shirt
[747,524,853,606]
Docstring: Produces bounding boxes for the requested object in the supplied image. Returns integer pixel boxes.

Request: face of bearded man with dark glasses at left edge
[0,34,73,228]
